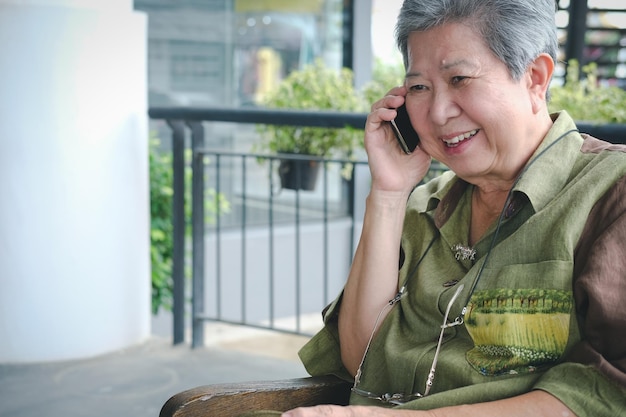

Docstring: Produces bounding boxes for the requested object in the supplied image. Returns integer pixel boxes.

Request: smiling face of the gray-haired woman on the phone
[405,23,540,183]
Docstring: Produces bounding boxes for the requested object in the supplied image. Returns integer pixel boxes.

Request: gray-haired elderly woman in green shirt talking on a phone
[280,0,626,417]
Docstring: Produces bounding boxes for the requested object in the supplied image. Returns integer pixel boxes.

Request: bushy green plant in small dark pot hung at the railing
[257,60,364,190]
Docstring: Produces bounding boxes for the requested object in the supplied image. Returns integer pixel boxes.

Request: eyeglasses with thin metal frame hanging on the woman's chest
[352,284,464,405]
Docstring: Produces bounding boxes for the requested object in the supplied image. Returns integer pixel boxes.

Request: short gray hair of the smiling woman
[395,0,559,80]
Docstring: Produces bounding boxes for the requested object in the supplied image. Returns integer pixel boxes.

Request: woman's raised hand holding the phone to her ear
[365,87,431,193]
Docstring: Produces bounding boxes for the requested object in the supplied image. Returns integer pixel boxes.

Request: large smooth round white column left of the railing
[0,0,150,363]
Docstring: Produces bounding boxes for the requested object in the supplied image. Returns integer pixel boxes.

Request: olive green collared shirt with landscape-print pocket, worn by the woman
[300,112,626,416]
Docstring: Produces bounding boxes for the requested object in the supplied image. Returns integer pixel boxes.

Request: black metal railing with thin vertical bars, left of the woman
[149,108,366,347]
